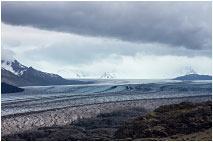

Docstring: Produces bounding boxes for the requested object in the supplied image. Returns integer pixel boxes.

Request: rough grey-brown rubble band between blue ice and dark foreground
[1,96,212,136]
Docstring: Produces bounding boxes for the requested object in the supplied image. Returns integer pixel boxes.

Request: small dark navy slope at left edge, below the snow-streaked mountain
[1,82,24,94]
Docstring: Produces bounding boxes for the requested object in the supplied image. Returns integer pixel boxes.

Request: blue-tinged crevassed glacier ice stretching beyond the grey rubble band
[1,80,212,116]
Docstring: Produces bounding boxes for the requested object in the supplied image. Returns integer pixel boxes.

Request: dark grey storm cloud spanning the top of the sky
[2,2,212,50]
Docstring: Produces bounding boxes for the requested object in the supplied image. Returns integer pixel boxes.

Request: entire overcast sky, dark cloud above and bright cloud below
[1,2,212,79]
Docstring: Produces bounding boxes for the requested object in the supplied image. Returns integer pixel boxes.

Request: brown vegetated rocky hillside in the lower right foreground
[115,101,212,140]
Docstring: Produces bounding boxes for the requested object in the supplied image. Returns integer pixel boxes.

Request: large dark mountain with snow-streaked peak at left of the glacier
[1,60,88,86]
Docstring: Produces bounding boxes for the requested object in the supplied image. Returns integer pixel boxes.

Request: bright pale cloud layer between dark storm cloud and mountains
[2,24,212,79]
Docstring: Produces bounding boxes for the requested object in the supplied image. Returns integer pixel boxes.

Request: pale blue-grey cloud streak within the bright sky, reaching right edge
[23,42,211,66]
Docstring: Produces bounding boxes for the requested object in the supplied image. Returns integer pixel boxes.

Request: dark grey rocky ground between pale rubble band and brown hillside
[2,108,147,141]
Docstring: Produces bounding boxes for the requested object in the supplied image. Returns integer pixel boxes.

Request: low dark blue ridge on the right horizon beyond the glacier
[173,74,212,80]
